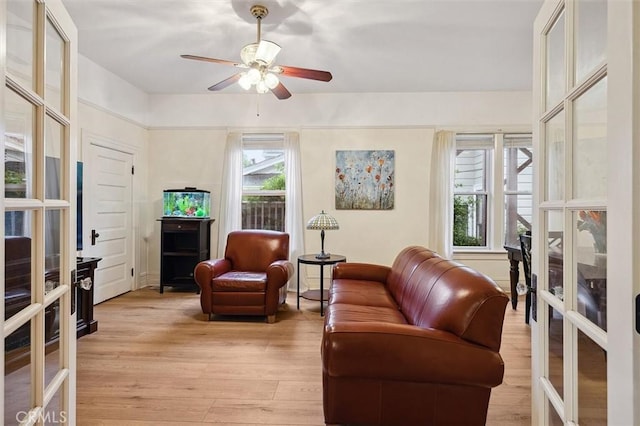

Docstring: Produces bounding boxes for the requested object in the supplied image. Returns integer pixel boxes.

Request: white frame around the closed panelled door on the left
[80,129,139,291]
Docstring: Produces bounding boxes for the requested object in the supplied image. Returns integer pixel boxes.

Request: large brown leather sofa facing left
[322,246,509,426]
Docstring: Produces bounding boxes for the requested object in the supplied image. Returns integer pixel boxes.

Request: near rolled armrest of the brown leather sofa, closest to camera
[322,322,504,387]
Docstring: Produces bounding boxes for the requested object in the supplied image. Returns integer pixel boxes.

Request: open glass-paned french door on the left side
[0,0,77,425]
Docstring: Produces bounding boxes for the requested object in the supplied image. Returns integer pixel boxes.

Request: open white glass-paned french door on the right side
[531,0,640,426]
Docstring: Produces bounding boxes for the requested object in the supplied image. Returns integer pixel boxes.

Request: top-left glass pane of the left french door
[6,0,35,90]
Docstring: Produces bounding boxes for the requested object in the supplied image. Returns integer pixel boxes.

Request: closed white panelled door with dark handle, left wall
[83,143,133,303]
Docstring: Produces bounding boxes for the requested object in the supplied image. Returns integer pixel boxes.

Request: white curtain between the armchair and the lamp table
[283,133,304,291]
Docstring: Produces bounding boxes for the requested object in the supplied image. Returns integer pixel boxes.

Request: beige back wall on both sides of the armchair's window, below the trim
[147,128,434,285]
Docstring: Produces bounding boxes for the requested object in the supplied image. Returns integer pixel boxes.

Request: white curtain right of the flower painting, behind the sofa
[429,131,456,259]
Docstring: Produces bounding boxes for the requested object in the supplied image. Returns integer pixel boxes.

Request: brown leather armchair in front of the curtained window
[194,230,293,323]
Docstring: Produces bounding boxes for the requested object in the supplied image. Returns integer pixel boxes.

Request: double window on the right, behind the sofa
[453,133,533,249]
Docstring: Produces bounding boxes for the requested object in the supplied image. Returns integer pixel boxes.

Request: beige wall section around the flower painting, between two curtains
[300,128,434,265]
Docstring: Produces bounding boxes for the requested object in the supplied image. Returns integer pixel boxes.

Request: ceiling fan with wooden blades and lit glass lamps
[180,4,333,99]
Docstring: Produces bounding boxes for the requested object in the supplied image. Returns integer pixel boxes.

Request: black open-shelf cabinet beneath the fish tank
[160,218,213,293]
